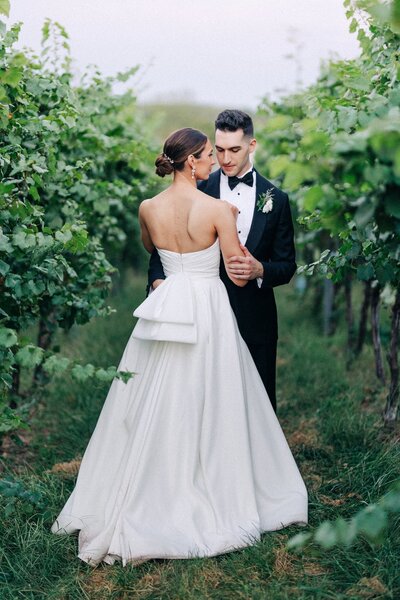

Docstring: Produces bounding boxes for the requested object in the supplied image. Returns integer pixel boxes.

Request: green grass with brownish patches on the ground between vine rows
[0,277,400,600]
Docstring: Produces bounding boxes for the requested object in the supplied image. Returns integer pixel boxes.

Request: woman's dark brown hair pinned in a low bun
[155,127,207,177]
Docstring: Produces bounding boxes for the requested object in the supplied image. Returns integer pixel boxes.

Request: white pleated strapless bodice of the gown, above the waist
[157,238,220,277]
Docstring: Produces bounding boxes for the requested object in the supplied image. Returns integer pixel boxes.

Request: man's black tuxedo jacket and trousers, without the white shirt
[145,170,296,408]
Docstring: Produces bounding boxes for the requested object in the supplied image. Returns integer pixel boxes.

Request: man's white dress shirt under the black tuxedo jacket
[219,167,262,287]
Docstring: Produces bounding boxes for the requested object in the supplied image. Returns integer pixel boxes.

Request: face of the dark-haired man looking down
[215,129,256,177]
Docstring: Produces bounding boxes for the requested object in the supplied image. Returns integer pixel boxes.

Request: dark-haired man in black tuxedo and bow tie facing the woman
[149,110,296,410]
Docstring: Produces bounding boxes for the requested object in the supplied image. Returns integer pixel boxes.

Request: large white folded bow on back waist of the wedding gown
[132,271,197,344]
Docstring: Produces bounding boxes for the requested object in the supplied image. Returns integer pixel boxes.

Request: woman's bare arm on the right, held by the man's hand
[214,202,247,287]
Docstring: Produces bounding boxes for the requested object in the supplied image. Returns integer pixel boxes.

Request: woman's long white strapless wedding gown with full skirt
[52,240,307,565]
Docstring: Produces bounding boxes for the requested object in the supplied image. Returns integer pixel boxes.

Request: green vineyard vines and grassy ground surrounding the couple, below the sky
[0,0,400,599]
